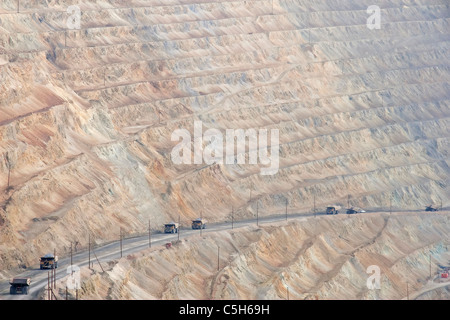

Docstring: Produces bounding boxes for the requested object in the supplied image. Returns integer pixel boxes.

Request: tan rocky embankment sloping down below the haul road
[48,212,450,299]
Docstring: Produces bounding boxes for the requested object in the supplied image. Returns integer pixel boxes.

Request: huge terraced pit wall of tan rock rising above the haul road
[0,0,450,270]
